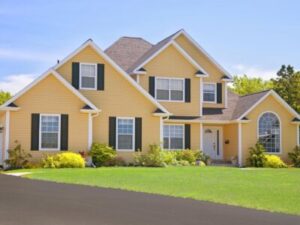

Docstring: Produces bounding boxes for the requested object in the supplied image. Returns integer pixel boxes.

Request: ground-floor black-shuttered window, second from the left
[117,118,135,150]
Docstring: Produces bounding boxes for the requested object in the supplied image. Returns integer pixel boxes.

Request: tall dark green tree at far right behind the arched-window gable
[272,65,300,113]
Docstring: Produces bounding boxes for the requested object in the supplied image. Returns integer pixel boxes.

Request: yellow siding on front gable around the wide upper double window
[140,45,200,116]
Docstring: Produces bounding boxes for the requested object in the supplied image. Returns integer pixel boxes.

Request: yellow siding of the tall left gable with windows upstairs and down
[57,47,160,159]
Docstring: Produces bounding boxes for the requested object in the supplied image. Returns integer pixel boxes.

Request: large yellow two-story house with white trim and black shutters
[0,30,300,166]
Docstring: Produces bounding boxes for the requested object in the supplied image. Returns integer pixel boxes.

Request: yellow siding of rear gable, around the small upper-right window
[175,34,225,108]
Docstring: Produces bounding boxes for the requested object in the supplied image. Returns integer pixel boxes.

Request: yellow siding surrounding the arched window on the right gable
[242,96,297,162]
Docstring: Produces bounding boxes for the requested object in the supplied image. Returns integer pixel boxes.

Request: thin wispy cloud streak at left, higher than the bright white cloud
[0,48,57,64]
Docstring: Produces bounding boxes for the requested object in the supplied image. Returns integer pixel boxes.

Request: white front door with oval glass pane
[203,126,223,159]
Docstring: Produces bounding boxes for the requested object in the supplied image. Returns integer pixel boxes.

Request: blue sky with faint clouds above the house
[0,0,300,92]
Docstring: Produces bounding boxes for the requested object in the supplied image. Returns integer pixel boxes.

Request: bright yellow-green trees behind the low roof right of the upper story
[231,75,273,95]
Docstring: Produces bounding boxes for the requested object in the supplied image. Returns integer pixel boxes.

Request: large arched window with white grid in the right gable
[258,112,280,153]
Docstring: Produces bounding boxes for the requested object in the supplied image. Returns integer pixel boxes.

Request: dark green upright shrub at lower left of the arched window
[247,142,266,167]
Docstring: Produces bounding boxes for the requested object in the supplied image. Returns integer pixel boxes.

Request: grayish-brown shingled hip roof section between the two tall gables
[105,37,153,71]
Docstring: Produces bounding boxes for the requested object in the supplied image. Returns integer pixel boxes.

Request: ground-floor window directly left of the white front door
[163,125,184,150]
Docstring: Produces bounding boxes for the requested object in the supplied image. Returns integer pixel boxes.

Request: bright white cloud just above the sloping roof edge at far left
[0,74,36,94]
